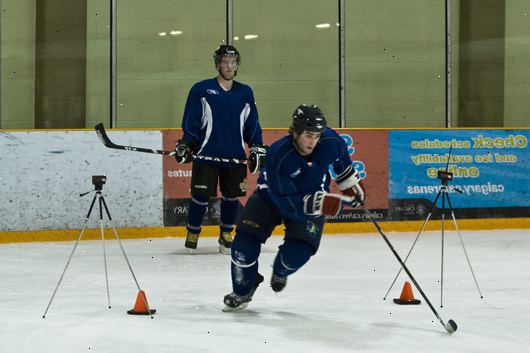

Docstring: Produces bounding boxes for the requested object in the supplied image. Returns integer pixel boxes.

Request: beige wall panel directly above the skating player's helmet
[234,0,339,128]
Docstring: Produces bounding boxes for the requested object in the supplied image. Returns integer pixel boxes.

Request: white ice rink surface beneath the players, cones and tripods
[0,230,530,353]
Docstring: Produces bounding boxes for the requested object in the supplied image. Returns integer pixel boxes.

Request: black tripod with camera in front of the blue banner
[383,169,484,308]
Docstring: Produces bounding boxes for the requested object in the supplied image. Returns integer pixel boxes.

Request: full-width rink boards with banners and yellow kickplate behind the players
[0,129,530,242]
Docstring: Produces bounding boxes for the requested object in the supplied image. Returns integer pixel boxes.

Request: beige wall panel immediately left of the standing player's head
[117,0,226,127]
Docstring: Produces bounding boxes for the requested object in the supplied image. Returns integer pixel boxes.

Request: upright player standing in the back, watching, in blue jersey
[175,45,266,254]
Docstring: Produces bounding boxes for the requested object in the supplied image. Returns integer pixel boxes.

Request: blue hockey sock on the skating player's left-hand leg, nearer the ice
[231,231,261,295]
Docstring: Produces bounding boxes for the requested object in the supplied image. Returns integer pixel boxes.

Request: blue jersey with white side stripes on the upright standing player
[182,78,263,164]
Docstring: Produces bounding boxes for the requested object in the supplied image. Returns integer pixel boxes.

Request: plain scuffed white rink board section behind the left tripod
[0,131,163,231]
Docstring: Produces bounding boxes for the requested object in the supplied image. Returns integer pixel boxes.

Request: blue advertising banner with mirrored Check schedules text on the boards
[389,130,530,218]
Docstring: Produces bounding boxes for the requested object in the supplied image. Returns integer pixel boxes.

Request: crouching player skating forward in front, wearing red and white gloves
[224,105,364,310]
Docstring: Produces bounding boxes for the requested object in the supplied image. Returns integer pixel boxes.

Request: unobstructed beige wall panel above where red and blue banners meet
[346,0,445,127]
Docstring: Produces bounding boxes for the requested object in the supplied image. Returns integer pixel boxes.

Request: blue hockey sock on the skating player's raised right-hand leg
[272,239,313,277]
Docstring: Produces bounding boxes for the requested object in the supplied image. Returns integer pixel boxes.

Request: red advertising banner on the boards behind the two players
[162,129,388,226]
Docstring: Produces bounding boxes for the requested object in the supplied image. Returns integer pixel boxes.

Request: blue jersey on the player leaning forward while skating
[257,128,352,220]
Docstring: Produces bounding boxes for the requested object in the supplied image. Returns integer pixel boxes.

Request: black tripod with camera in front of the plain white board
[42,175,155,319]
